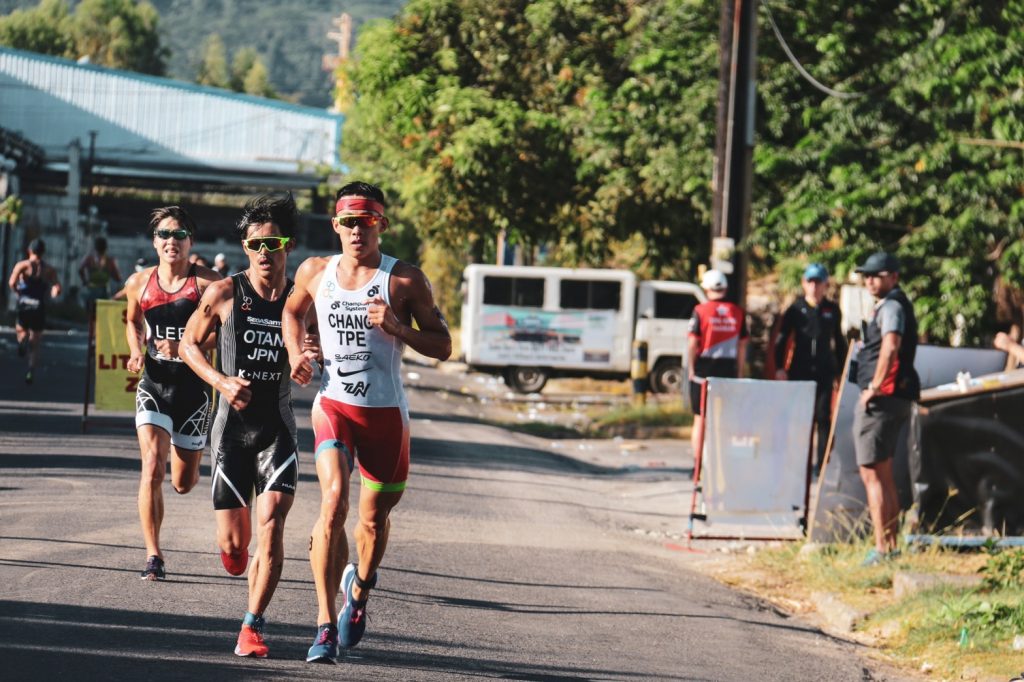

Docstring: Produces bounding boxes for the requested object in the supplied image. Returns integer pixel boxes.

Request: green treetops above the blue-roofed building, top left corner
[0,0,167,75]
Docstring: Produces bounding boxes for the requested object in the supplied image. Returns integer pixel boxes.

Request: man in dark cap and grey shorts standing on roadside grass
[853,252,921,565]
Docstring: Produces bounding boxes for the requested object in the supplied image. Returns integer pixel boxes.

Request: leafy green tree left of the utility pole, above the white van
[343,0,716,275]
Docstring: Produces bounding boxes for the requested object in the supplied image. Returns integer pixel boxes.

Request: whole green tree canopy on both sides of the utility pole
[343,0,1024,342]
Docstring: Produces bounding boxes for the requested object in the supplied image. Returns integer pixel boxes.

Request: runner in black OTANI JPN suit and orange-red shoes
[181,195,315,657]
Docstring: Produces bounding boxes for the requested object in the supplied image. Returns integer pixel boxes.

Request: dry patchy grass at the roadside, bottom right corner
[733,542,1024,680]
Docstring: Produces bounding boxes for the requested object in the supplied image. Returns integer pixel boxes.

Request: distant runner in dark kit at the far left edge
[7,239,60,384]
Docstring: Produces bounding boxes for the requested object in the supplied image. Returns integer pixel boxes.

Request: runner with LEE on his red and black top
[125,206,220,581]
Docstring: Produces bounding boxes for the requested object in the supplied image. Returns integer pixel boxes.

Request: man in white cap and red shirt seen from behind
[687,270,750,456]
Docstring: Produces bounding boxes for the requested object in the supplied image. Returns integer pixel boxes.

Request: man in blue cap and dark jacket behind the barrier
[775,263,846,472]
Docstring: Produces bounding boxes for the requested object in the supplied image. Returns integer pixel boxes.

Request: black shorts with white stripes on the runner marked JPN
[211,406,299,509]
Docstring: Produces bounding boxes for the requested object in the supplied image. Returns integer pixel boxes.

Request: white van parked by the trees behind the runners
[462,264,705,393]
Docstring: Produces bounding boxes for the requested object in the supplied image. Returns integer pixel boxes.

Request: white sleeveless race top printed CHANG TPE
[313,254,408,405]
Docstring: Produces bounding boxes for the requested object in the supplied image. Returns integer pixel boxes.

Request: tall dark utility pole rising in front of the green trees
[711,0,758,306]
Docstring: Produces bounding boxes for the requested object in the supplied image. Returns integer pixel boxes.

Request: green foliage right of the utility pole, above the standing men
[751,0,1024,343]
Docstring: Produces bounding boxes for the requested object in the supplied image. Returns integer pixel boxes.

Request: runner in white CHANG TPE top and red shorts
[282,182,452,663]
